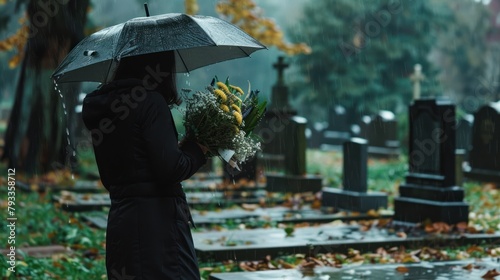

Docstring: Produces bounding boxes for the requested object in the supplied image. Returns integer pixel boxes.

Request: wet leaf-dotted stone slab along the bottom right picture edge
[210,258,500,280]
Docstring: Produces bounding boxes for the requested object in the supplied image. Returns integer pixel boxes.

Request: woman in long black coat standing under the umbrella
[83,52,206,280]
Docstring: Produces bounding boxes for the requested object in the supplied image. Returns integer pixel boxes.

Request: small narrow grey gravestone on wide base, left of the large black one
[322,138,387,213]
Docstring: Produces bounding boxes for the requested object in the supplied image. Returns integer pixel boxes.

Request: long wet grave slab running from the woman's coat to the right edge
[193,224,500,261]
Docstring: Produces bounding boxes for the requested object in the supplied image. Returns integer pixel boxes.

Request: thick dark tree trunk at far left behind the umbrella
[2,0,89,174]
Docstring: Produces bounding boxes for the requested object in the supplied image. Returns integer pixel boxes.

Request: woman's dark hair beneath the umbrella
[113,51,181,105]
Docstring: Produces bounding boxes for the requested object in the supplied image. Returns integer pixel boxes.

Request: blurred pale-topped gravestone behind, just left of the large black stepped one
[359,110,400,157]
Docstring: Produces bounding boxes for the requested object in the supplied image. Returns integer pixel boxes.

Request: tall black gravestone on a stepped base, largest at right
[394,99,469,224]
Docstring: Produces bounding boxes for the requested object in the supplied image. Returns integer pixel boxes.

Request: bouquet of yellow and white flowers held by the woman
[183,76,267,169]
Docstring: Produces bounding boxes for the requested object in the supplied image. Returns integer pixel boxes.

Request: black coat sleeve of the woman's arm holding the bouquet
[142,92,206,185]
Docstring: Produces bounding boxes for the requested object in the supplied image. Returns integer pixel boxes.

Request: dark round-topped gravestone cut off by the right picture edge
[464,101,500,182]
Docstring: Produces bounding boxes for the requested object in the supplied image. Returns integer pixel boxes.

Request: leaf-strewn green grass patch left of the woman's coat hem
[0,192,105,280]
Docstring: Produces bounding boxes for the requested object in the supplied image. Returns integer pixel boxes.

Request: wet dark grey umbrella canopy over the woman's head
[52,13,266,83]
